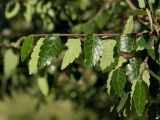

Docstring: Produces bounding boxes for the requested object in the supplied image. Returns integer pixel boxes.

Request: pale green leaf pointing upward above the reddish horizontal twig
[123,16,134,34]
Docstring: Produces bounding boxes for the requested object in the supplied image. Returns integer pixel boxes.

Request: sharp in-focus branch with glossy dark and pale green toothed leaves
[3,0,160,116]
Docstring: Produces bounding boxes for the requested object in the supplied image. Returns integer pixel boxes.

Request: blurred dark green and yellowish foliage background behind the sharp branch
[0,0,160,120]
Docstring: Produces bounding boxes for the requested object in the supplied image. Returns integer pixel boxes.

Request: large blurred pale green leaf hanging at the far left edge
[3,49,19,79]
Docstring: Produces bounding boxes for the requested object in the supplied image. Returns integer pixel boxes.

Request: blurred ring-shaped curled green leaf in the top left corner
[5,0,20,19]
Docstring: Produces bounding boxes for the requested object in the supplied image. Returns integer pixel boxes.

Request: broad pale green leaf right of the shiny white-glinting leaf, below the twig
[100,39,116,70]
